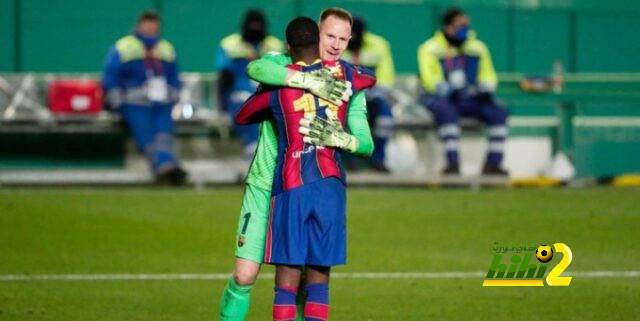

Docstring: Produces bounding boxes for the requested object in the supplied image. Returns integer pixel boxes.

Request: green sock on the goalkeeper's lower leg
[220,278,253,321]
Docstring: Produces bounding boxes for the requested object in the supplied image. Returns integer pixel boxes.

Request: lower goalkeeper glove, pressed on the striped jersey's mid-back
[298,108,358,153]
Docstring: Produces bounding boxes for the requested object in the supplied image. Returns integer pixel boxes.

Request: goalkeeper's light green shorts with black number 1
[236,184,271,264]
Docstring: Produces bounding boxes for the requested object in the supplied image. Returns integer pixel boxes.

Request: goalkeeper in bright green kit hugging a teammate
[221,8,373,321]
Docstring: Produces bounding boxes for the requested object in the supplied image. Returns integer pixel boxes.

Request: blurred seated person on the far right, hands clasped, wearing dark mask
[418,8,508,175]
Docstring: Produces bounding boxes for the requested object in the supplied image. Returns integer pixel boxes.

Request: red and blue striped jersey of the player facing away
[235,60,376,195]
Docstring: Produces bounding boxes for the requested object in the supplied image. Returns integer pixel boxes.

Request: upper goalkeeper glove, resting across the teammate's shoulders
[287,68,353,106]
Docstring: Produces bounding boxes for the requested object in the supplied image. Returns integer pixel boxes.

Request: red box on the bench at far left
[49,79,102,114]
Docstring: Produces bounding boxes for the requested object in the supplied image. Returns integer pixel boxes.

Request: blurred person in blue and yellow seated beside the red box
[102,11,187,185]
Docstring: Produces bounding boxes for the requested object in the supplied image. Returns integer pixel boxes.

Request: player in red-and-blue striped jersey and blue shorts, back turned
[235,17,375,321]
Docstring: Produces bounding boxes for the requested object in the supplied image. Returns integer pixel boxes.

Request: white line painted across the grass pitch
[0,271,640,282]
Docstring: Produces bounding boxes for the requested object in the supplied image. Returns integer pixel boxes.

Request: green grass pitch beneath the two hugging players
[0,188,640,321]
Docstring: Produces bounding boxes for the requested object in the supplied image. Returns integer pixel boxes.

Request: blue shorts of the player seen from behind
[264,177,347,266]
